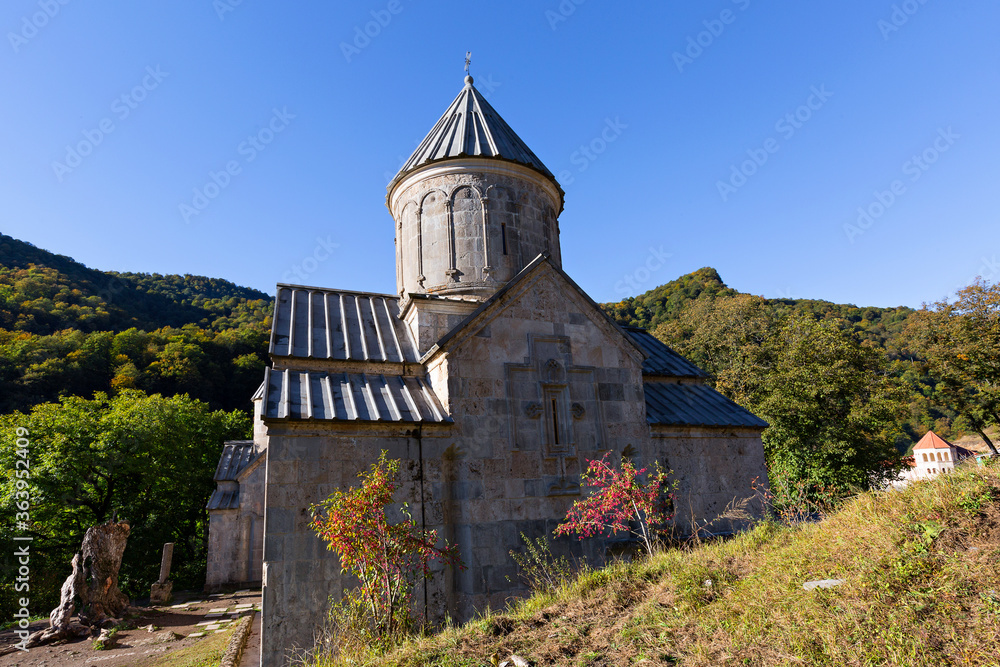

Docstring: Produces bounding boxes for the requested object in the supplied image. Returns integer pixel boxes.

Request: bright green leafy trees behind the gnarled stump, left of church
[0,390,250,612]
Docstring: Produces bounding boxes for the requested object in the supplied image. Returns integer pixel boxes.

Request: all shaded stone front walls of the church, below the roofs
[254,258,767,665]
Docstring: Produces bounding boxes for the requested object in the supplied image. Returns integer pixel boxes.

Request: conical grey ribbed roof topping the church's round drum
[389,76,555,189]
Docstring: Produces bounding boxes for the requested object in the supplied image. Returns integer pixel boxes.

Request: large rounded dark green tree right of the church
[754,317,906,495]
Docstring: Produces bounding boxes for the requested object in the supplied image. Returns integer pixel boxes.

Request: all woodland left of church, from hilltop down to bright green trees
[0,236,273,617]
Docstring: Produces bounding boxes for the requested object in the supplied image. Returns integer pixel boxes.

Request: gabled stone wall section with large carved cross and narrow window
[414,265,651,621]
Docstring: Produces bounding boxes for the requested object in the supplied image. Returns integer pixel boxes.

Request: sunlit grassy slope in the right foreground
[370,465,1000,666]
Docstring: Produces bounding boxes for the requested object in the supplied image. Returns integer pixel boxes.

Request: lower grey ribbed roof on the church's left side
[264,369,451,422]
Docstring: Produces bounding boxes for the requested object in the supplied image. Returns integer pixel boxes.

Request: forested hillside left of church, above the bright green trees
[0,235,273,413]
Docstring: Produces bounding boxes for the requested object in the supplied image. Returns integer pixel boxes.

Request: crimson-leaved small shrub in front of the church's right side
[555,454,673,556]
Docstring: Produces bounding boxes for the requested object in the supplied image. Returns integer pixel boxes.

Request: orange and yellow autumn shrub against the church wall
[311,450,463,636]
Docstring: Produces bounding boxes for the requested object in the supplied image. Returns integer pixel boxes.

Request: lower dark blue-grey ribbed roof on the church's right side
[643,382,767,428]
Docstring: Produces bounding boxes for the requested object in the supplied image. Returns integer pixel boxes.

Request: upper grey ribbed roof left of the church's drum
[271,284,417,362]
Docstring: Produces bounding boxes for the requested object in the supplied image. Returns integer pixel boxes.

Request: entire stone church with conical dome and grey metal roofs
[209,76,767,667]
